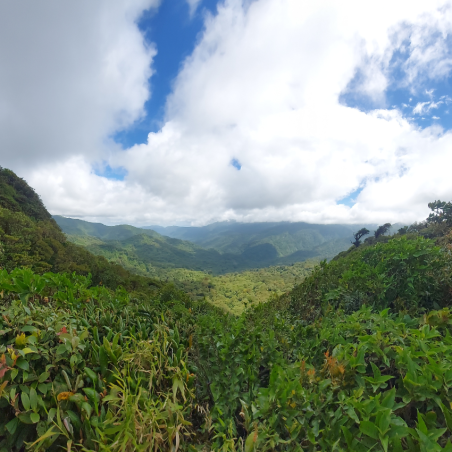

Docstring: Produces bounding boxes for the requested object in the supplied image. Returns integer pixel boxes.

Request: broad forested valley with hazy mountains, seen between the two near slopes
[53,216,368,314]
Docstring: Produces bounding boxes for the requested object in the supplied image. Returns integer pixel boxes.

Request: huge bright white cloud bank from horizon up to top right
[4,0,452,224]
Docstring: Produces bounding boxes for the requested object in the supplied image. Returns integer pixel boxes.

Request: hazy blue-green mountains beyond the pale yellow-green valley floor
[54,216,384,274]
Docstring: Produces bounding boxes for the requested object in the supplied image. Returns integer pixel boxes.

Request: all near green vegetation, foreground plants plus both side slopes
[0,170,452,452]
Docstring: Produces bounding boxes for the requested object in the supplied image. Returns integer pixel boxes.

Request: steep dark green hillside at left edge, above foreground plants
[0,169,160,292]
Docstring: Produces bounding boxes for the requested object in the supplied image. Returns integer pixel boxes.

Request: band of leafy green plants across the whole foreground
[0,260,452,451]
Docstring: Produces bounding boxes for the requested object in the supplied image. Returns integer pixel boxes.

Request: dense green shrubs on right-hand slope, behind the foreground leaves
[290,236,452,321]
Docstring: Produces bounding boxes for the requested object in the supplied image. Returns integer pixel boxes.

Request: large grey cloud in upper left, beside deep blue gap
[0,0,158,171]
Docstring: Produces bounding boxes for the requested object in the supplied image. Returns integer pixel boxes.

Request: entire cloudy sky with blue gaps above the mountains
[0,0,452,226]
